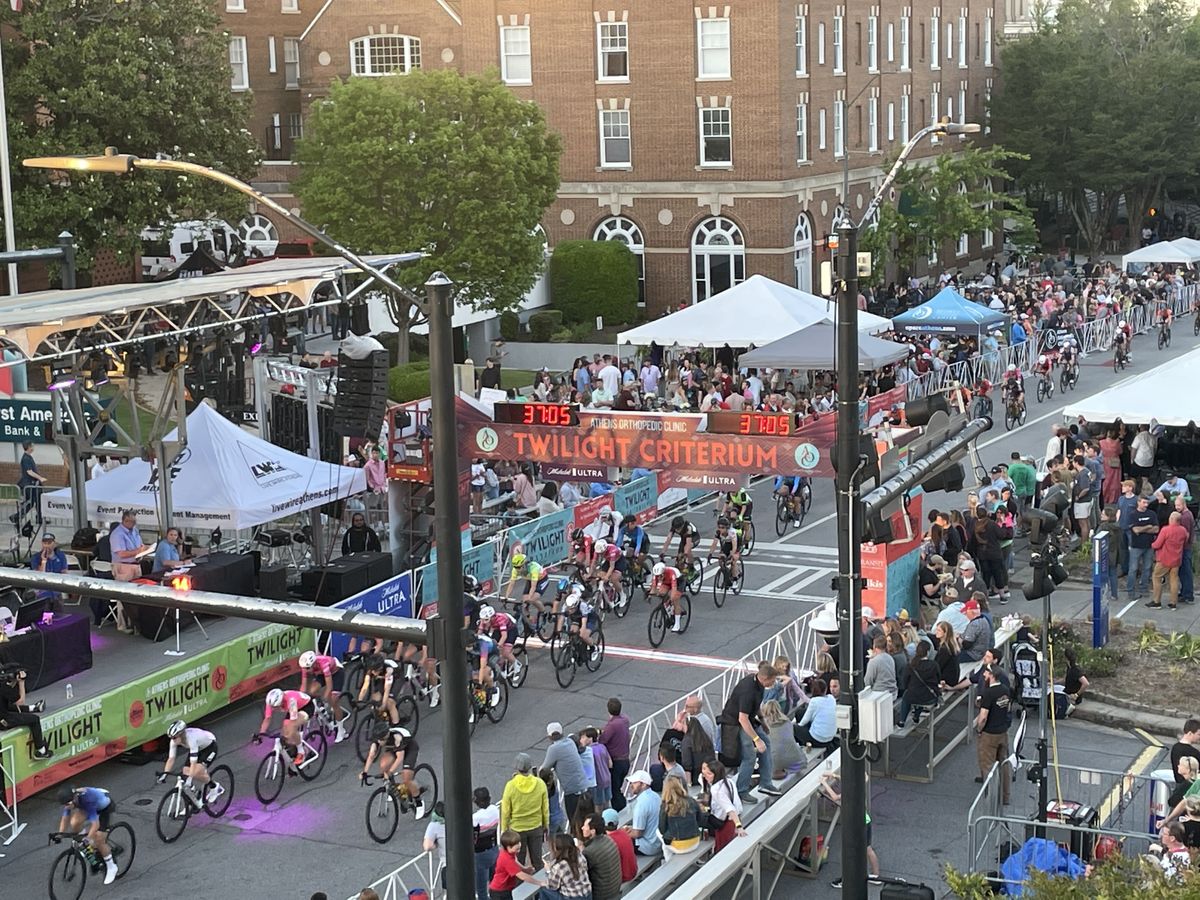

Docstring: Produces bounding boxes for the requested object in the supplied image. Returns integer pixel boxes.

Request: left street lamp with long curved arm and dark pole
[23,146,475,898]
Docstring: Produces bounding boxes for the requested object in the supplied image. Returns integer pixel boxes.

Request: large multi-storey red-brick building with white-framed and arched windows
[217,0,1006,313]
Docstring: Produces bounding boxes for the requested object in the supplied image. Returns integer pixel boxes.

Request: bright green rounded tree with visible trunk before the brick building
[295,70,562,359]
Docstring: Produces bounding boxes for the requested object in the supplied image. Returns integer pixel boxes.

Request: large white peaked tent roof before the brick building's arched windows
[617,275,890,347]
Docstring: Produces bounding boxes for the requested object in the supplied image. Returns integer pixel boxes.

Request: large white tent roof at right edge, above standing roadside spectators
[1062,349,1200,427]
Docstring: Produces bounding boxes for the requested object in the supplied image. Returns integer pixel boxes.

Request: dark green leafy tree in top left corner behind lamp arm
[7,0,259,268]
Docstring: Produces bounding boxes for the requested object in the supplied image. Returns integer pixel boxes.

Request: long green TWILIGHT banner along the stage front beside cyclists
[0,625,316,799]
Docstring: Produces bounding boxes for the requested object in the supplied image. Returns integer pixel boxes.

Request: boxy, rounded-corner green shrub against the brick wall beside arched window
[550,241,637,325]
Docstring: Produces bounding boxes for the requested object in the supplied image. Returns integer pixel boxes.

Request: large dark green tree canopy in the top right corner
[991,0,1200,253]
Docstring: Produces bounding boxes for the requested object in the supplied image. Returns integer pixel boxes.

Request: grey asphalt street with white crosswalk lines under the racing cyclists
[0,329,1194,900]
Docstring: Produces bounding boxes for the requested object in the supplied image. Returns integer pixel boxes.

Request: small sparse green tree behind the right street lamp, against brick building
[859,146,1034,278]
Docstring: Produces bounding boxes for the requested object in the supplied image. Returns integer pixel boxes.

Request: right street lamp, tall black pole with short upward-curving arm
[834,119,979,900]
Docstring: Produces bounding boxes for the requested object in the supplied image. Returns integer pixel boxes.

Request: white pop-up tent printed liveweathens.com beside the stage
[42,403,367,529]
